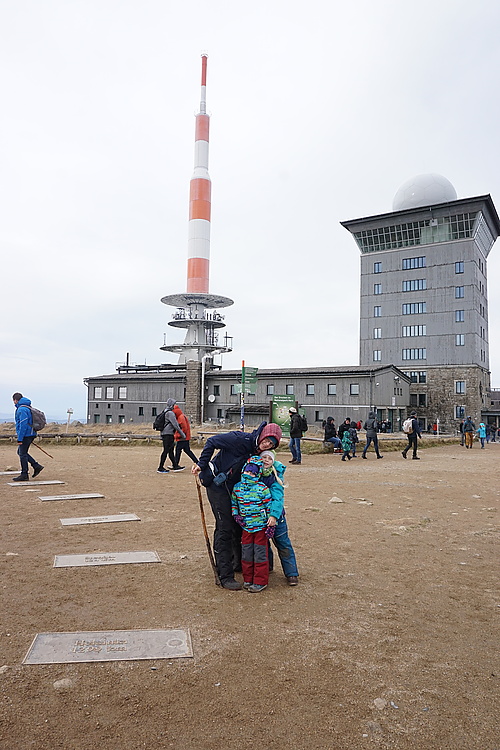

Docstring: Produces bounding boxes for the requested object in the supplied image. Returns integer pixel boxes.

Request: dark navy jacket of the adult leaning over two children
[198,422,267,489]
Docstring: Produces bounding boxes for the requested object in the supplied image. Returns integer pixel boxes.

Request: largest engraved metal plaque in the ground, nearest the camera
[23,630,193,664]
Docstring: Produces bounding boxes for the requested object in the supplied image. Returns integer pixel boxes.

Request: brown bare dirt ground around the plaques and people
[0,444,500,750]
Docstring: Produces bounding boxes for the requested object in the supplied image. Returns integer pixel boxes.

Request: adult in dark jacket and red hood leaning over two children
[191,422,281,591]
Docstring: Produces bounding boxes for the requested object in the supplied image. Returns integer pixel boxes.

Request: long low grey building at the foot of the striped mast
[85,363,410,430]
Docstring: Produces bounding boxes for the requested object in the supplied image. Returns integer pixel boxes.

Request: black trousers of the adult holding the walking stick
[207,483,241,581]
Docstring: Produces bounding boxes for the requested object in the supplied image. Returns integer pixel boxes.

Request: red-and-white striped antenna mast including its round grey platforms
[160,55,233,364]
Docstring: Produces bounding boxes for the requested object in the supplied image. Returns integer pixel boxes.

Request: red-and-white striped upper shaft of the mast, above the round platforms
[187,55,211,294]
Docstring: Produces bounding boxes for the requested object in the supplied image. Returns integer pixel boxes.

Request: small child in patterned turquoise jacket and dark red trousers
[231,456,283,594]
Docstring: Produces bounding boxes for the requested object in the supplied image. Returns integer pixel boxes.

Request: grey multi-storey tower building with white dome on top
[341,174,500,428]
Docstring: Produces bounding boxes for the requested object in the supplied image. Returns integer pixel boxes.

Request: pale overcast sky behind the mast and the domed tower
[0,0,500,420]
